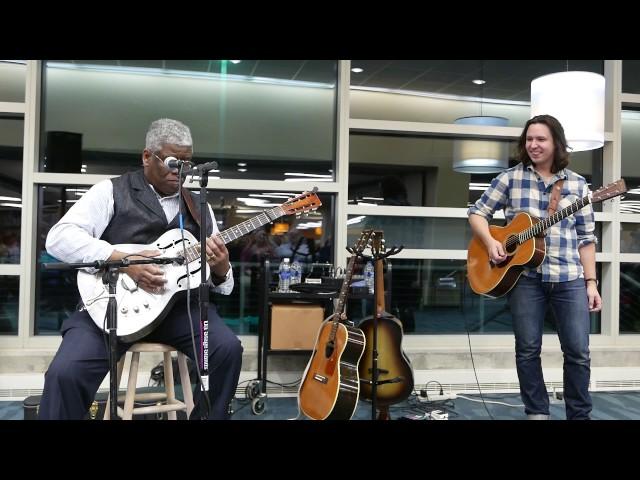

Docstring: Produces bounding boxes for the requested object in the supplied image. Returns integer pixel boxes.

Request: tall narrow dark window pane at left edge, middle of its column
[0,116,24,263]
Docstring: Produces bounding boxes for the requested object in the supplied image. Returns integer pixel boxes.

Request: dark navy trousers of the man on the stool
[39,301,243,420]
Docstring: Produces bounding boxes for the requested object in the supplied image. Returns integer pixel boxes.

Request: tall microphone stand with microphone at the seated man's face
[185,162,218,419]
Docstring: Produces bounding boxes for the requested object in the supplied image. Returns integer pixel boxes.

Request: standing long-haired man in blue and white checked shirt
[468,115,602,420]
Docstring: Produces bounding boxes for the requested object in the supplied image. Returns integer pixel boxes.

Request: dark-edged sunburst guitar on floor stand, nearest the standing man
[358,230,414,419]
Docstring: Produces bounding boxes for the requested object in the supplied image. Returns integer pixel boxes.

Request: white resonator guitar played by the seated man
[78,188,322,342]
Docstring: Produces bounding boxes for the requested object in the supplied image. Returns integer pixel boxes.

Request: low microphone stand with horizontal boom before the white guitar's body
[42,257,184,420]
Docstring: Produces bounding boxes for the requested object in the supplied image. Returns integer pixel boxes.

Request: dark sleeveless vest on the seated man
[100,170,212,245]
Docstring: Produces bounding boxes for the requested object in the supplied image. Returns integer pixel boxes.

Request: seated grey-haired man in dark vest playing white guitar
[39,118,242,419]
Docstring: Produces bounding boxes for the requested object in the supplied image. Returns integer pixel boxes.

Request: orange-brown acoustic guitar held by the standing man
[467,179,627,298]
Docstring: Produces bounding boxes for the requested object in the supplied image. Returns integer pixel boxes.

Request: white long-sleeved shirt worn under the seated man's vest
[46,180,233,295]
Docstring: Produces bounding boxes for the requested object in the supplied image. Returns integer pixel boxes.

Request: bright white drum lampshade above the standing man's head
[531,72,605,152]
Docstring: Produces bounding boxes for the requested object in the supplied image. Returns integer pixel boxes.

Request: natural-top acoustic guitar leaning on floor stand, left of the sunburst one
[298,230,372,420]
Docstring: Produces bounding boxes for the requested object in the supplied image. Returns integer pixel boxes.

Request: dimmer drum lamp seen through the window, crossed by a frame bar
[453,116,509,173]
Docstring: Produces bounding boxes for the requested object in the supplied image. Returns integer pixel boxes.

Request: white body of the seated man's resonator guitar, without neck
[78,228,210,342]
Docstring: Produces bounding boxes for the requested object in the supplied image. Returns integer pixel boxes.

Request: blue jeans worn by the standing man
[509,276,592,420]
